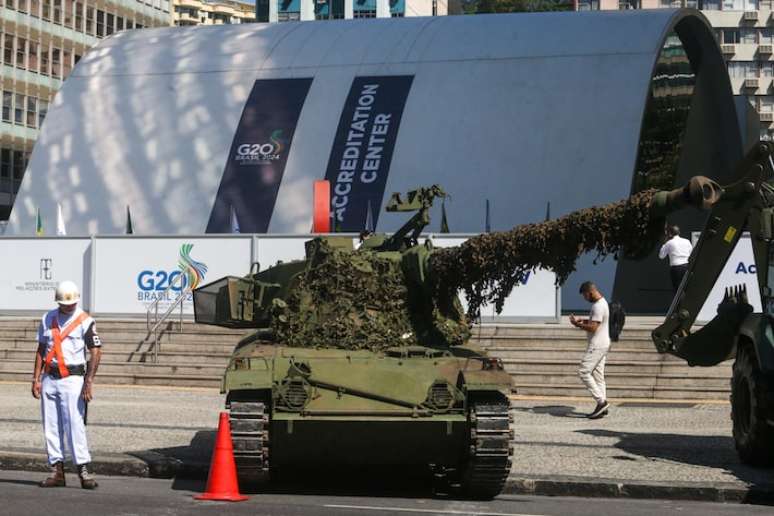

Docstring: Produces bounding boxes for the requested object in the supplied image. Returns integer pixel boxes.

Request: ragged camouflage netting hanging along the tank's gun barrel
[430,190,664,320]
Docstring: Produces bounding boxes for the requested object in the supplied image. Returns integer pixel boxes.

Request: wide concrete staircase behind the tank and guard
[0,318,731,399]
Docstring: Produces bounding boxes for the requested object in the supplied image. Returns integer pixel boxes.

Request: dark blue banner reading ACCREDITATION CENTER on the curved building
[325,75,414,231]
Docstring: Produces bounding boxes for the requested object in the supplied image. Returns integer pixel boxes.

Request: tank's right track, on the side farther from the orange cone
[460,396,513,500]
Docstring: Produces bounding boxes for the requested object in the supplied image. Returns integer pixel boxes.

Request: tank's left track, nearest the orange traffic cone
[229,401,269,486]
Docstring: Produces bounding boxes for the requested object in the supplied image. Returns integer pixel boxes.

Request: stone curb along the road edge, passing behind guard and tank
[0,450,774,505]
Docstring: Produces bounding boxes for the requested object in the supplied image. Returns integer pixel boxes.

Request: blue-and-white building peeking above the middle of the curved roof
[255,0,449,23]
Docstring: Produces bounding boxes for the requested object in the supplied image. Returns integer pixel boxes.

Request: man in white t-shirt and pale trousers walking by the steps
[570,281,610,419]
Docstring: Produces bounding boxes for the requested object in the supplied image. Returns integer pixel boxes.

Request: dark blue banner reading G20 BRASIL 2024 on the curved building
[206,79,312,233]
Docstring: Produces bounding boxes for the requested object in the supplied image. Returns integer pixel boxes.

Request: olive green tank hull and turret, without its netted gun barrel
[194,187,512,499]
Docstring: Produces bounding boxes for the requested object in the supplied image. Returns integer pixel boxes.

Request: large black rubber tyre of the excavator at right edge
[731,343,774,466]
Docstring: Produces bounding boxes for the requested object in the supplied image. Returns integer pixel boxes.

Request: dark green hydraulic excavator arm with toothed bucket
[652,143,774,366]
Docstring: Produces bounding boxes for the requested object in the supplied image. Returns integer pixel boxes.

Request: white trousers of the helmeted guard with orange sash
[40,374,91,466]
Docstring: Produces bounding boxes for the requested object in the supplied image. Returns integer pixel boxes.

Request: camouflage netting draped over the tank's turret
[272,239,470,351]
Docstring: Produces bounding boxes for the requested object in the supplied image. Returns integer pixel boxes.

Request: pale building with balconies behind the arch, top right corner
[578,0,774,140]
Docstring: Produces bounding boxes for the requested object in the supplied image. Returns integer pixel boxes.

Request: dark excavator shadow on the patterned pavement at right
[577,429,774,491]
